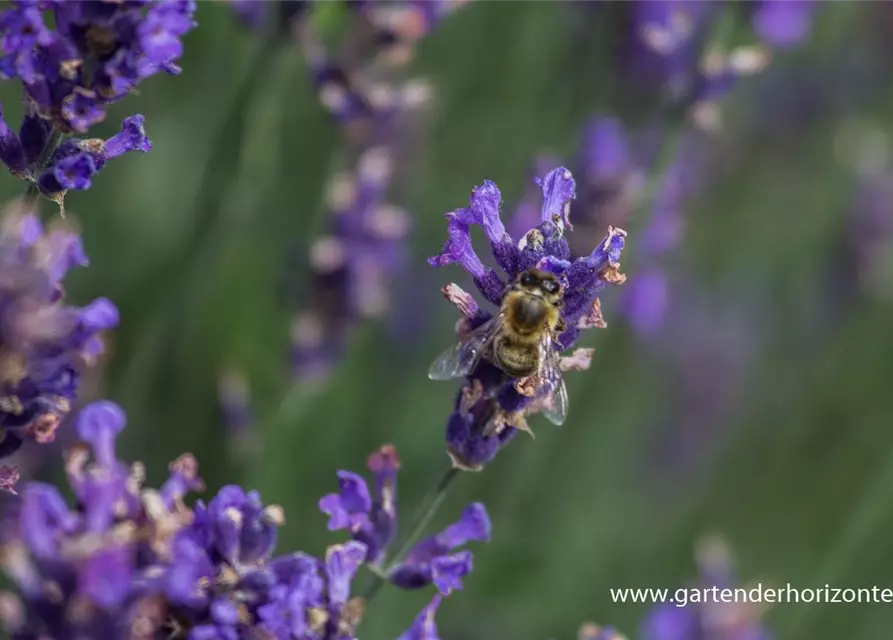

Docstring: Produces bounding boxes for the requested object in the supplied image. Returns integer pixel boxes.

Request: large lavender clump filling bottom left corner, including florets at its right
[0,401,490,640]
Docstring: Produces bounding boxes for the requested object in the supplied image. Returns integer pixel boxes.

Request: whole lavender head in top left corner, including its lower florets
[0,0,195,205]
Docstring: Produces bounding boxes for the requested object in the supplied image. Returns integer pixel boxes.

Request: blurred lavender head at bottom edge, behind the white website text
[640,539,773,640]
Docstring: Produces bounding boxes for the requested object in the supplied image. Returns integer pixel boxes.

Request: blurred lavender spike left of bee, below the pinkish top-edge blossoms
[290,17,430,380]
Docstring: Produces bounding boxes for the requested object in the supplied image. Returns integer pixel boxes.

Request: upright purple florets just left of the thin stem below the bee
[319,445,400,567]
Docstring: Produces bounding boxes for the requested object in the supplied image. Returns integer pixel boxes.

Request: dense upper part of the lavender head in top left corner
[0,0,196,133]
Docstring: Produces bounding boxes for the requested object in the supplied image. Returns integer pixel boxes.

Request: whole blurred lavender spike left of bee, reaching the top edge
[282,1,461,380]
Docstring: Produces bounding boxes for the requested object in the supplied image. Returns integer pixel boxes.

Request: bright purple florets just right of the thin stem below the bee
[388,502,491,596]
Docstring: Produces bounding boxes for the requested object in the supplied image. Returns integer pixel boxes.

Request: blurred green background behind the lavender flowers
[0,0,893,640]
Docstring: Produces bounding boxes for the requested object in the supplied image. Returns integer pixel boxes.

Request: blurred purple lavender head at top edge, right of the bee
[627,0,815,129]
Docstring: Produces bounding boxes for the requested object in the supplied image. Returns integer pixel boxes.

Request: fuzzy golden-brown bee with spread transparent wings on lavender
[428,269,567,425]
